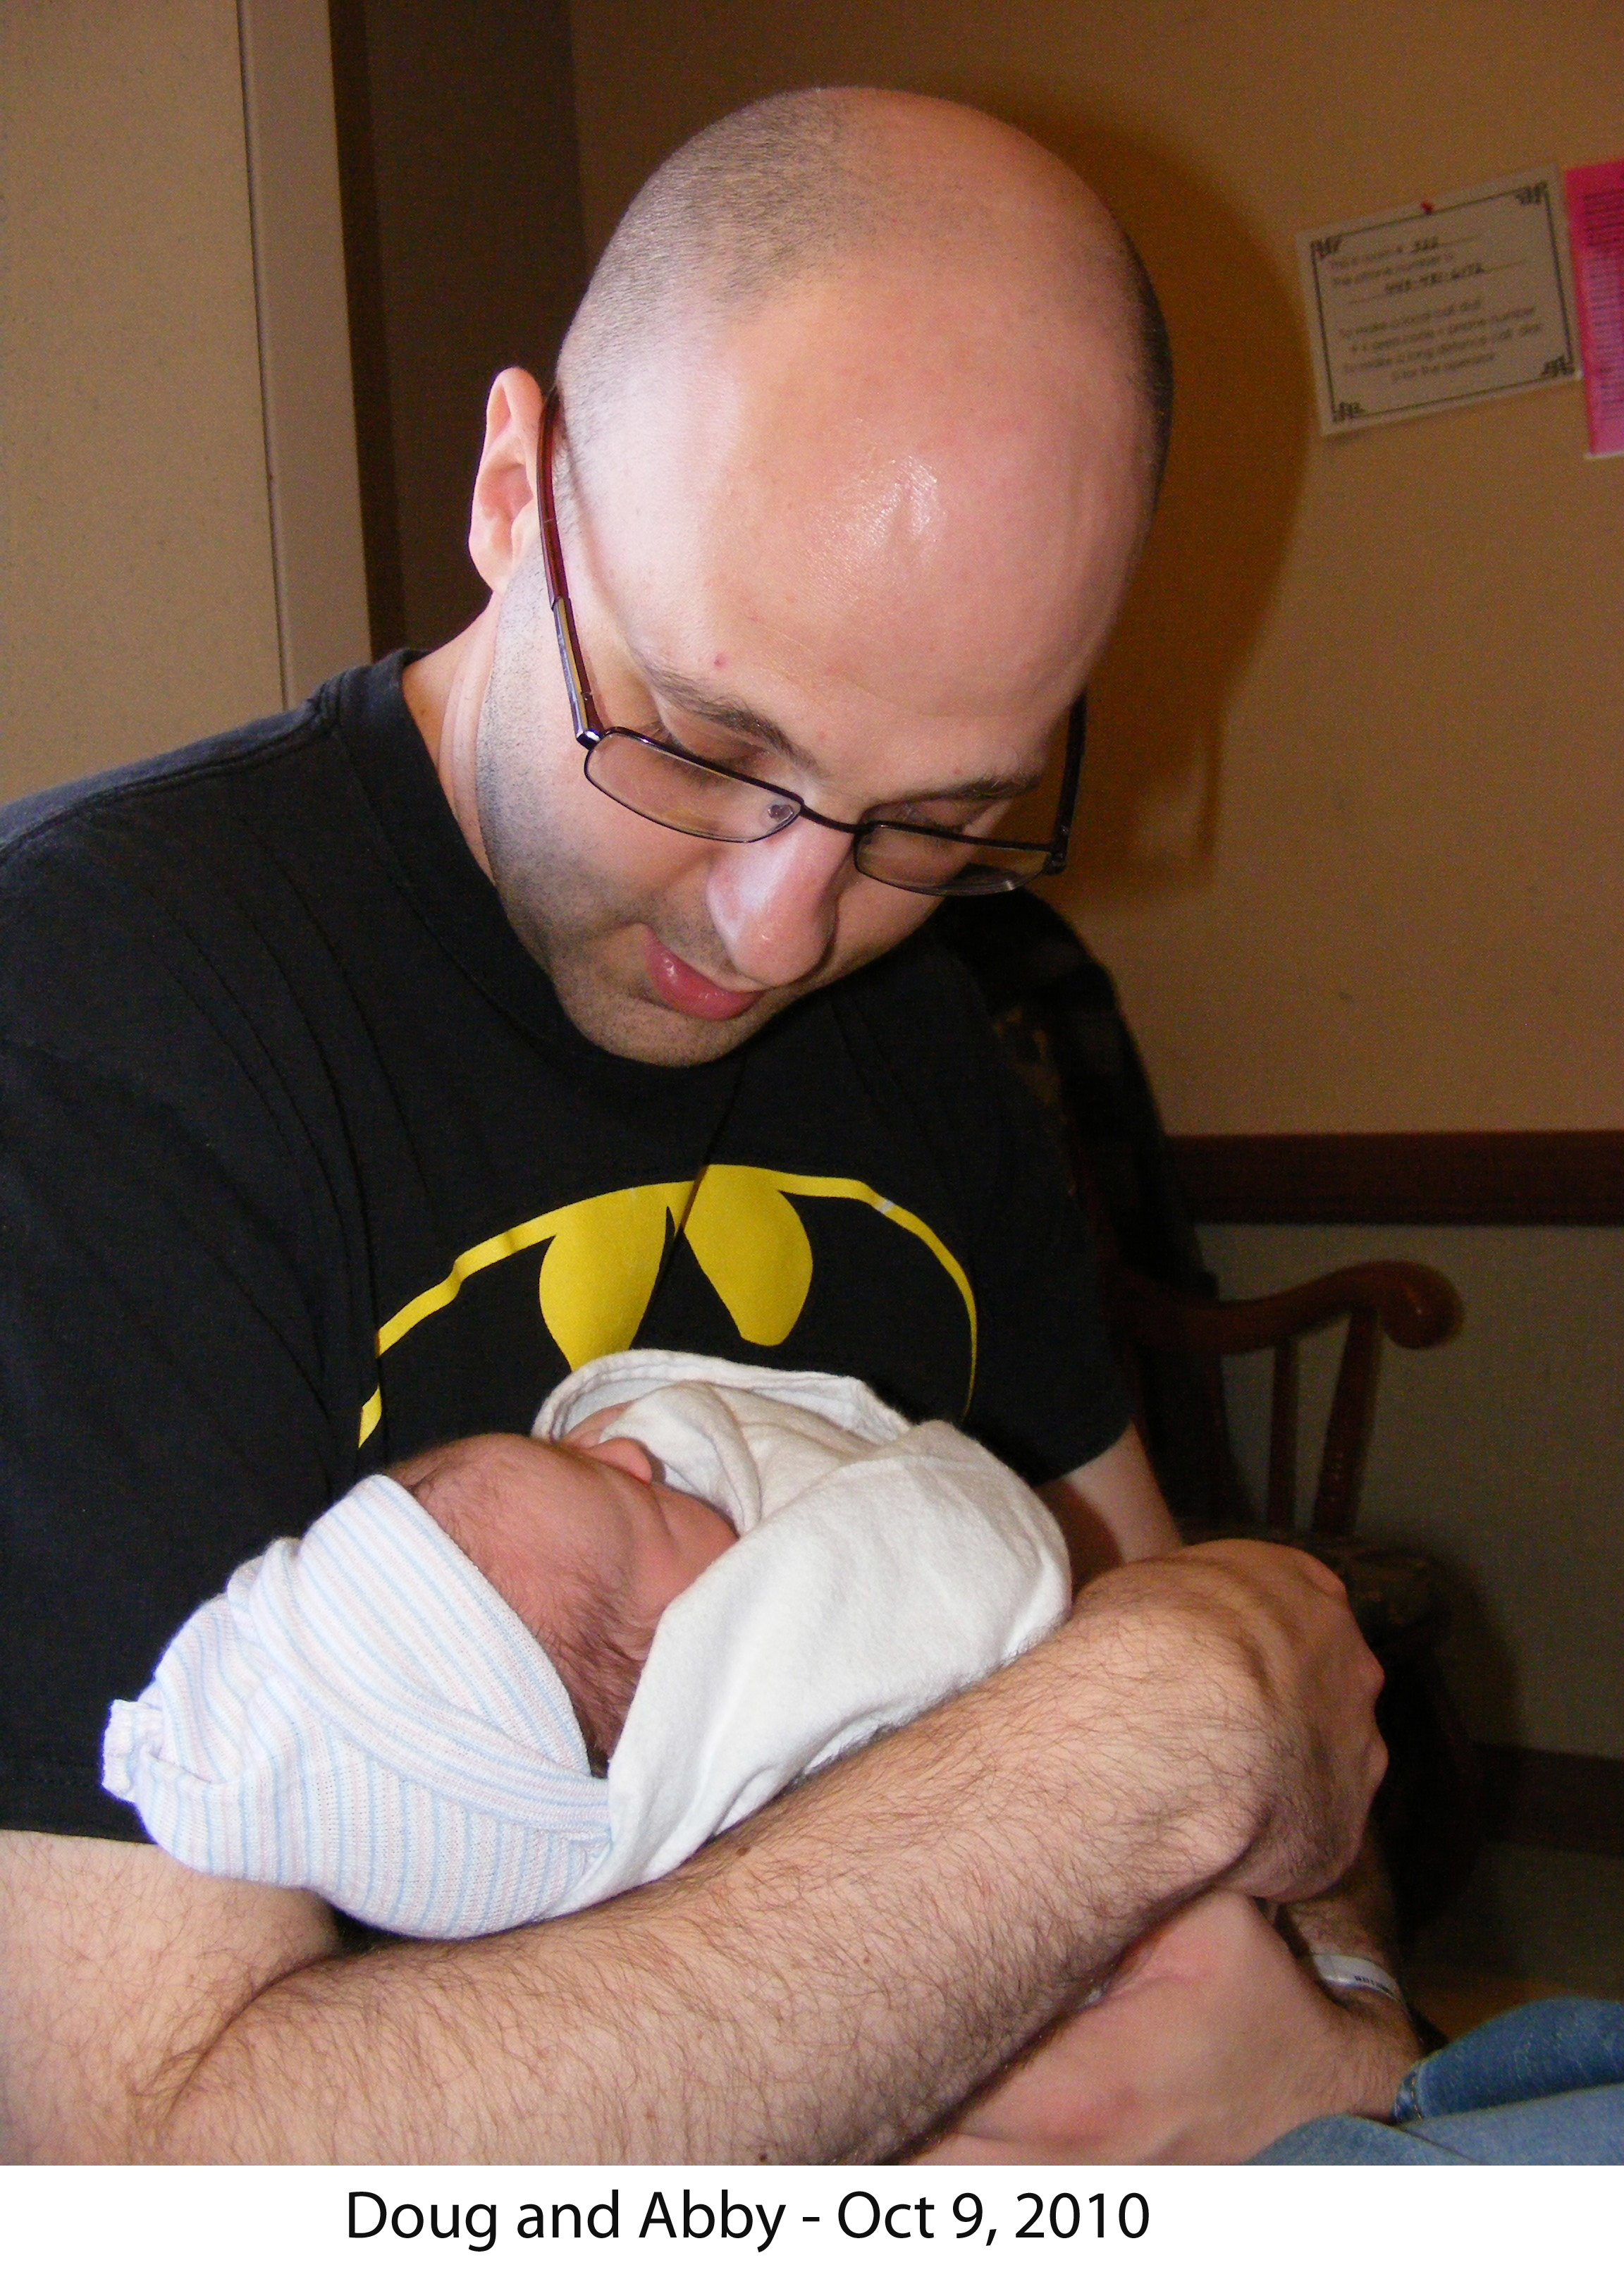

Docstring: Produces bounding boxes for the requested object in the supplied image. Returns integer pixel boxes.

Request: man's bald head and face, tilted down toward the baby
[457,89,1165,1062]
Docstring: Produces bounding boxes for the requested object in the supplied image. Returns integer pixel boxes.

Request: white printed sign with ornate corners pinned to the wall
[1298,167,1578,436]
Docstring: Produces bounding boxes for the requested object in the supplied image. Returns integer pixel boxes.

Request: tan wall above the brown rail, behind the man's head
[573,0,1624,1133]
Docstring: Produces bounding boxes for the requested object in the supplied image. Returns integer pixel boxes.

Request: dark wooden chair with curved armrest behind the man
[937,895,1482,1932]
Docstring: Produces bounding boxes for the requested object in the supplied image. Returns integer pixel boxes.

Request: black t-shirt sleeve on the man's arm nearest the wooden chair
[964,1007,1133,1482]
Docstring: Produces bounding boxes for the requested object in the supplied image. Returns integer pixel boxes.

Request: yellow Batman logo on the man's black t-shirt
[361,1165,976,1444]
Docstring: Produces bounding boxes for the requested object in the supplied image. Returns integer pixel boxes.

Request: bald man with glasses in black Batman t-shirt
[0,94,1414,2161]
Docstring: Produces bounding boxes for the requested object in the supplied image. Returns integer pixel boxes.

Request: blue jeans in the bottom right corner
[1252,1998,1624,2166]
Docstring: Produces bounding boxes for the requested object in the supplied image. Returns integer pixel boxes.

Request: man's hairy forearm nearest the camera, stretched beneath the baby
[153,1590,1247,2163]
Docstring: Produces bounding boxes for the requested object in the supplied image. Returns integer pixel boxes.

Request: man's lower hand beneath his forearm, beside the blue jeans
[921,1896,1421,2166]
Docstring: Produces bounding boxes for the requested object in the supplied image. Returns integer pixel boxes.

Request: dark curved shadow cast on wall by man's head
[998,103,1313,914]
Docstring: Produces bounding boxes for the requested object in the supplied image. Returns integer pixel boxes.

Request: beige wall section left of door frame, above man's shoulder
[0,0,281,797]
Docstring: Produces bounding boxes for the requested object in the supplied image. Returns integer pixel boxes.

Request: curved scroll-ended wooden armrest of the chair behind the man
[1105,1260,1462,1357]
